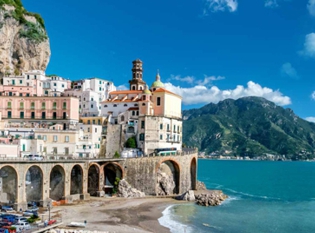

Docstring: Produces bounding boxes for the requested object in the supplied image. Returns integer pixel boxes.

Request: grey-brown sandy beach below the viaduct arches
[51,197,183,233]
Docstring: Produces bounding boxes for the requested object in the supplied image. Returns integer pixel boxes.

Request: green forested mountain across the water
[183,97,315,160]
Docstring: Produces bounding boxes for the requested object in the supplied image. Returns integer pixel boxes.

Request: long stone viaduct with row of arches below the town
[0,152,197,210]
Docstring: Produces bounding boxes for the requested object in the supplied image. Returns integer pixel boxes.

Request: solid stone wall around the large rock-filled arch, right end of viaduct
[119,153,197,195]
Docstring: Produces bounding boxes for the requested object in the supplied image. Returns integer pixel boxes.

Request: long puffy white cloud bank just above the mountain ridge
[165,81,291,106]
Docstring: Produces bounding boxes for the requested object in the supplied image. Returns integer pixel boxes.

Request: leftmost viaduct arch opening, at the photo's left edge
[0,165,17,204]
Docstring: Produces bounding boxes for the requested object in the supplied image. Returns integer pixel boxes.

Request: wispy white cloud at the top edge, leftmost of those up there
[203,0,238,15]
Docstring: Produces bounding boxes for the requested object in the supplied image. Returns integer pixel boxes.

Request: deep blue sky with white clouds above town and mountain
[22,0,315,122]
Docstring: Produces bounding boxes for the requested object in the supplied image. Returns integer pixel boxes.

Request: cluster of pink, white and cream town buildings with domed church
[0,59,182,160]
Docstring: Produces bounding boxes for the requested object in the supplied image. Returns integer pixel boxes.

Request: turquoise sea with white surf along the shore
[159,159,315,233]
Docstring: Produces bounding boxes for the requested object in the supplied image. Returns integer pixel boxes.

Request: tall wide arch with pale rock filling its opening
[156,159,180,195]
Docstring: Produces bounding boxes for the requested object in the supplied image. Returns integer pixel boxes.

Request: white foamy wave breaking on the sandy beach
[158,205,193,233]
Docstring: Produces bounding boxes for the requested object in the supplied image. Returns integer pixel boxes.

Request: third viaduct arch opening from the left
[49,165,66,201]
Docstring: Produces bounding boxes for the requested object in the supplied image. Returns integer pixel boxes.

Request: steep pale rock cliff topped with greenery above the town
[0,0,50,78]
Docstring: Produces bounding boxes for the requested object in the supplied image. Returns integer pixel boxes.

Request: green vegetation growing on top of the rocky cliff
[0,0,47,43]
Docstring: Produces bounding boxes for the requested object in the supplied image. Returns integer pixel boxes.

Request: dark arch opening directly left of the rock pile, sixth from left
[102,162,124,193]
